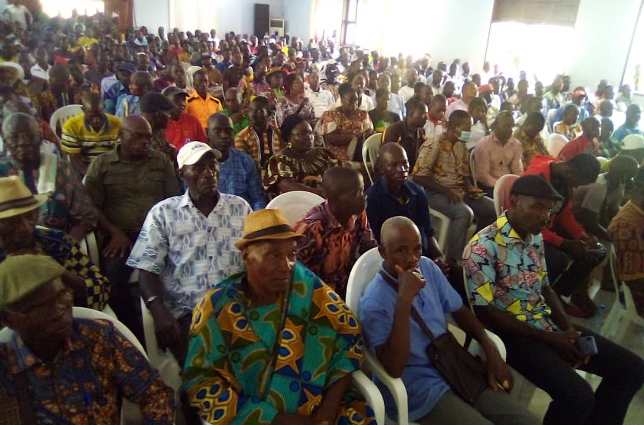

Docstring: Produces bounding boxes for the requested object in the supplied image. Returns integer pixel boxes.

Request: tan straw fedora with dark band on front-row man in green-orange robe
[235,209,302,249]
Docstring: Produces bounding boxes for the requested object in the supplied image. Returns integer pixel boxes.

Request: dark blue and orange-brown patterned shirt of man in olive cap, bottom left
[0,319,174,425]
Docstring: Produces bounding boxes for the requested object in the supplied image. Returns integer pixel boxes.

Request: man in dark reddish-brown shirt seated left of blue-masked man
[382,99,428,169]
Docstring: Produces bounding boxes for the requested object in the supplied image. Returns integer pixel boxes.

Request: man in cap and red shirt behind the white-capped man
[162,86,206,151]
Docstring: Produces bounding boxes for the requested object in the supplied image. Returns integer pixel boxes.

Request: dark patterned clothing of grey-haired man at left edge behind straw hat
[0,140,98,232]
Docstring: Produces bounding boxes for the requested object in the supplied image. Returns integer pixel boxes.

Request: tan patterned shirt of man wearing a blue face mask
[413,135,472,194]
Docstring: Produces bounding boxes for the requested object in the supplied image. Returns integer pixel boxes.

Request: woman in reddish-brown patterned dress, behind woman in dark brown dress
[316,83,373,161]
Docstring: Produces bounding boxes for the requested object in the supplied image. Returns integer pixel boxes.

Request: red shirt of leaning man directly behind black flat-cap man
[523,155,586,246]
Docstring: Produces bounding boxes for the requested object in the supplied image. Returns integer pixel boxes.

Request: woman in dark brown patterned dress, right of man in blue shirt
[264,115,338,196]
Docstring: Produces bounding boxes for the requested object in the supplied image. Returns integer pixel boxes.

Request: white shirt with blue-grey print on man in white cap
[127,191,252,317]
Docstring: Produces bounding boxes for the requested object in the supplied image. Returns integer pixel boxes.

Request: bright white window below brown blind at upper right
[486,22,575,85]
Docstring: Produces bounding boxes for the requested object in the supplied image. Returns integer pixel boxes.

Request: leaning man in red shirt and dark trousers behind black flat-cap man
[525,154,605,317]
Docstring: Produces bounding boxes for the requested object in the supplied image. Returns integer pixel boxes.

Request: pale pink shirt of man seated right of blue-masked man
[473,133,523,187]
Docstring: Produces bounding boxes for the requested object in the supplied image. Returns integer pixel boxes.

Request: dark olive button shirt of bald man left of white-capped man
[85,146,179,233]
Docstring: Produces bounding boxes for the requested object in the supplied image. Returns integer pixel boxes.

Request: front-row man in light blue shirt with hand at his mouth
[360,217,539,425]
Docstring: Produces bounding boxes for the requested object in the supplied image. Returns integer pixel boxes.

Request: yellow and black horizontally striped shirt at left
[60,114,121,163]
